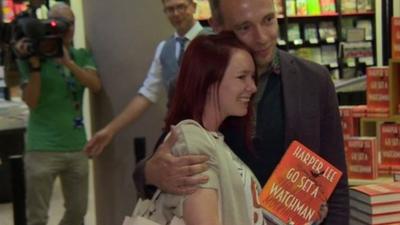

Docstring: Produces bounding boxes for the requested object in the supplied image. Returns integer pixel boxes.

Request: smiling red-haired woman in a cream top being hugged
[156,33,265,225]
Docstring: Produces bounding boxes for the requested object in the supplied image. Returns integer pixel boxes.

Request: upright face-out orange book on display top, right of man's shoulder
[367,66,389,112]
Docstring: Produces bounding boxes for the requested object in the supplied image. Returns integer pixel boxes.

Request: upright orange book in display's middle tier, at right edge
[380,123,400,166]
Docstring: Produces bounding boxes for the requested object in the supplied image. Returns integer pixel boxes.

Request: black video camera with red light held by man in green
[0,13,70,59]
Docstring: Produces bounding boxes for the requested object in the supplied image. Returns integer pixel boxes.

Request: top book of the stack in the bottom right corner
[349,182,400,204]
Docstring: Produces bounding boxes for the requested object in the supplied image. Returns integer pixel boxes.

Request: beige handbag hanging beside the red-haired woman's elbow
[122,190,185,225]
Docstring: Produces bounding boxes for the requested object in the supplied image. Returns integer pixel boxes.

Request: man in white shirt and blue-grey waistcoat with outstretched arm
[85,0,203,156]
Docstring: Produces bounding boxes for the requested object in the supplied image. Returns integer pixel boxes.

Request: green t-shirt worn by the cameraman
[18,48,96,152]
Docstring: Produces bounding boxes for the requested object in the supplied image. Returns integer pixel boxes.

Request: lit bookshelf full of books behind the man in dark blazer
[274,0,377,80]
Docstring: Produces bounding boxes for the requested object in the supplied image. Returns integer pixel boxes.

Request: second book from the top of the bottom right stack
[350,198,400,215]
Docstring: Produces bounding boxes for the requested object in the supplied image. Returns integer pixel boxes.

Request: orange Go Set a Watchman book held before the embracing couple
[259,141,342,224]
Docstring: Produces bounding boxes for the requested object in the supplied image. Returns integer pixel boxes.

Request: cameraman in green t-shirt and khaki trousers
[15,3,101,225]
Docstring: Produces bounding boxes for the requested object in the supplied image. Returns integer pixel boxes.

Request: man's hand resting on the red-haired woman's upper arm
[144,126,208,194]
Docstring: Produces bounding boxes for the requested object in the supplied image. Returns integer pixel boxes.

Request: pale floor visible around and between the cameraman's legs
[0,163,96,225]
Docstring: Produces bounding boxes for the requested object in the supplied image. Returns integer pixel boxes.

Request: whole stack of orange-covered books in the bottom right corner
[350,182,400,225]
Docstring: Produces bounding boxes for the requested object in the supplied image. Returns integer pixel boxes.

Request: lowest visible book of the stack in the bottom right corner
[350,208,400,224]
